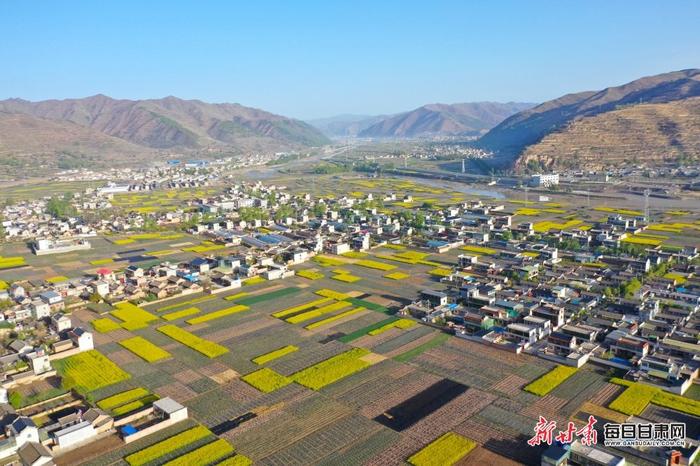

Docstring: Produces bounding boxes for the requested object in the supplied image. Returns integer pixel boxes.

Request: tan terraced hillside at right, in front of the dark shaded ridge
[516,97,700,169]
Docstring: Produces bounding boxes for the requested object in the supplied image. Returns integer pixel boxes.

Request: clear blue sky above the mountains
[0,0,700,118]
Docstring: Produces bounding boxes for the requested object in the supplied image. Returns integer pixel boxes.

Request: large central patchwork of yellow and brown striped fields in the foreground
[68,251,636,465]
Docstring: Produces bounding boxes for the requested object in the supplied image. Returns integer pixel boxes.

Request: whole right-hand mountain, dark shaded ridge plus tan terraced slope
[477,69,700,170]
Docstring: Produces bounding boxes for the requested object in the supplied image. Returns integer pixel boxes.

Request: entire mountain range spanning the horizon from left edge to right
[0,69,700,174]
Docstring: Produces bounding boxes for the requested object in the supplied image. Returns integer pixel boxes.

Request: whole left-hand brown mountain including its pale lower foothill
[0,95,330,173]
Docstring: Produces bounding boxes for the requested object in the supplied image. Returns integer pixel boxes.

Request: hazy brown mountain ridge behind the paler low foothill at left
[0,95,328,151]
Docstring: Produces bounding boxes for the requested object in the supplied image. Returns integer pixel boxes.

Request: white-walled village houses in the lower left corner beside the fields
[0,282,188,466]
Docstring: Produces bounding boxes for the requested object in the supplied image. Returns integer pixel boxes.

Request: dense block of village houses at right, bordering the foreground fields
[403,206,700,393]
